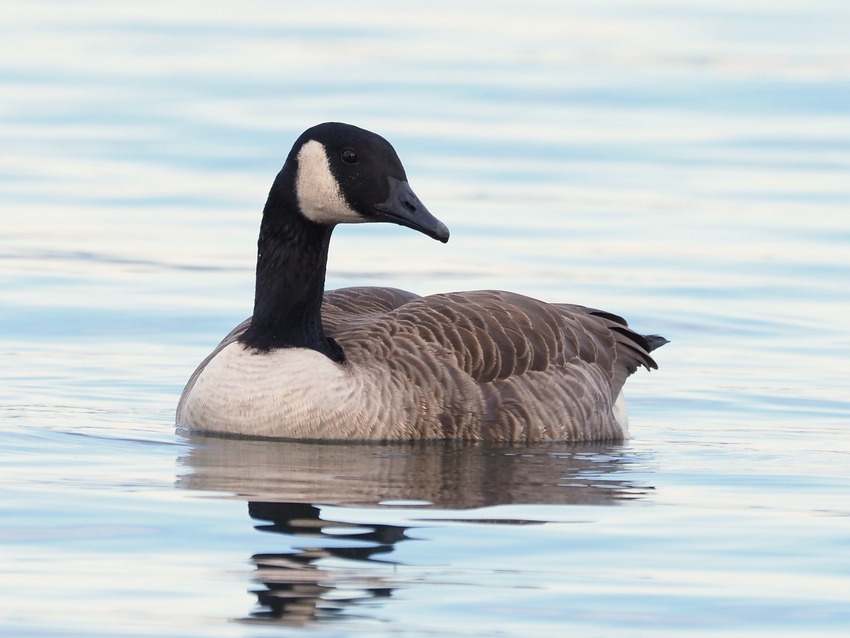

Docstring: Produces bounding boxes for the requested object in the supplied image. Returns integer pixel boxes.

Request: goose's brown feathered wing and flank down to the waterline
[325,289,656,440]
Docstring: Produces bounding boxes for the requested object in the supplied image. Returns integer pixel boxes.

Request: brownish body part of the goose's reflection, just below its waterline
[179,436,646,509]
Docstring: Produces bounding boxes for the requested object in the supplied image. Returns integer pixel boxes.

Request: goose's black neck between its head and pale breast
[239,172,344,361]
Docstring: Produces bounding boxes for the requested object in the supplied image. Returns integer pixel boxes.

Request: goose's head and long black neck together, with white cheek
[239,122,449,361]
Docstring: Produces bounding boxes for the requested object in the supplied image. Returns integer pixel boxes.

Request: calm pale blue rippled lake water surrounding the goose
[0,0,850,637]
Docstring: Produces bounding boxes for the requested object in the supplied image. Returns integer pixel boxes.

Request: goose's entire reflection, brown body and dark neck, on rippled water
[178,437,651,625]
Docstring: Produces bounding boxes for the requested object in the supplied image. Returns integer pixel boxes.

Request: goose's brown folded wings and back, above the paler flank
[322,288,657,384]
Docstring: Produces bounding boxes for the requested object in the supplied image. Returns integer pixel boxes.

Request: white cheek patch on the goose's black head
[295,140,367,224]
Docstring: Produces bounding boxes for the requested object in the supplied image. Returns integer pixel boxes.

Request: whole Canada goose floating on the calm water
[177,123,666,442]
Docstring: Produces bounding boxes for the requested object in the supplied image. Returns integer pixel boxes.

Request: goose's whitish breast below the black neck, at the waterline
[178,342,374,439]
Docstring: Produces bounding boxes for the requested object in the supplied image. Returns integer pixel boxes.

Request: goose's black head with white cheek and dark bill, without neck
[285,122,449,242]
